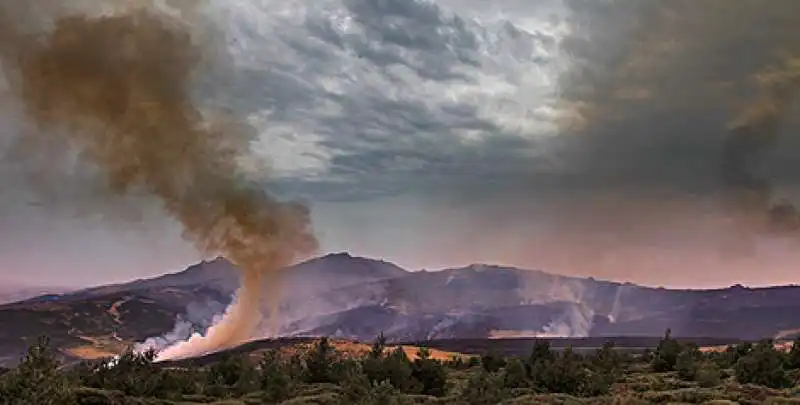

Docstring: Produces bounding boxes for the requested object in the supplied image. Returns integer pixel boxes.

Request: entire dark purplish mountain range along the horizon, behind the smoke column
[0,253,800,364]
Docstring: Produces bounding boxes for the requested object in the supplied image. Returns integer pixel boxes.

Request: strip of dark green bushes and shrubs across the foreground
[0,332,800,405]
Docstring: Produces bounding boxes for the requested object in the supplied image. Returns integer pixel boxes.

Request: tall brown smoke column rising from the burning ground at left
[0,1,316,359]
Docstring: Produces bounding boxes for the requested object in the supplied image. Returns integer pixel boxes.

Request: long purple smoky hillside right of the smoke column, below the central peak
[286,266,800,340]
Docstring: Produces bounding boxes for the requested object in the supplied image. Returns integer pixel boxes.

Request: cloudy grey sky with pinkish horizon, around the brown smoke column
[0,0,800,287]
